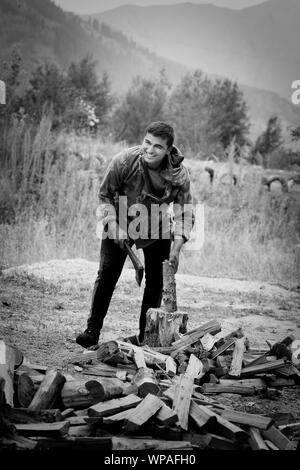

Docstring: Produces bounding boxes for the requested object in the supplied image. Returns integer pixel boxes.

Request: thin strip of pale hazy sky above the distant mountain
[55,0,266,14]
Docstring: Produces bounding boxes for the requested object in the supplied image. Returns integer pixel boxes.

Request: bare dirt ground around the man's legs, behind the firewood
[0,259,300,413]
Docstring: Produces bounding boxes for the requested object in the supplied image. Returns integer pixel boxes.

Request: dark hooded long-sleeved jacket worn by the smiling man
[99,145,194,248]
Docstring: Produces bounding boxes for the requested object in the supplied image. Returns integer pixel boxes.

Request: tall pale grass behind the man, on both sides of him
[0,117,300,285]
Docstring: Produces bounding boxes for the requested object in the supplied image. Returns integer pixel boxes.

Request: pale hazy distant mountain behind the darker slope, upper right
[93,0,300,99]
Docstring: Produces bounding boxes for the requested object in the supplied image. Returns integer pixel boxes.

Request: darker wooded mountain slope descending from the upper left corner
[0,0,187,92]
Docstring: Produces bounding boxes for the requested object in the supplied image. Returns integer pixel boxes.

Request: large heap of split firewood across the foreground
[0,320,300,452]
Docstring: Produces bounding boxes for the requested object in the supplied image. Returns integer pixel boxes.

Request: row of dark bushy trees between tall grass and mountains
[0,51,300,166]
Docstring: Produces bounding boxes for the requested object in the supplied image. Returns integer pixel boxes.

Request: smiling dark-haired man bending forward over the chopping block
[76,122,194,348]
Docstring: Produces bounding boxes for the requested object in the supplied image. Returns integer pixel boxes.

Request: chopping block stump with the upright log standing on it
[143,260,188,347]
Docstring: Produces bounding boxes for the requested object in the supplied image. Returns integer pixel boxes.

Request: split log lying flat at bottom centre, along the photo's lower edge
[112,437,192,452]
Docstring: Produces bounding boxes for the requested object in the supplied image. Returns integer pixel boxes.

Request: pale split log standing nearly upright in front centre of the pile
[172,374,194,431]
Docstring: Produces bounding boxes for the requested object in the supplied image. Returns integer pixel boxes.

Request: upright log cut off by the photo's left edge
[0,340,15,406]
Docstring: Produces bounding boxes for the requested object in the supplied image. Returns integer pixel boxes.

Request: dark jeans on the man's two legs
[87,238,171,341]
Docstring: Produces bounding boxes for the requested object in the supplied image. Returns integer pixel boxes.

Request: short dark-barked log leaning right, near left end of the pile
[28,369,66,410]
